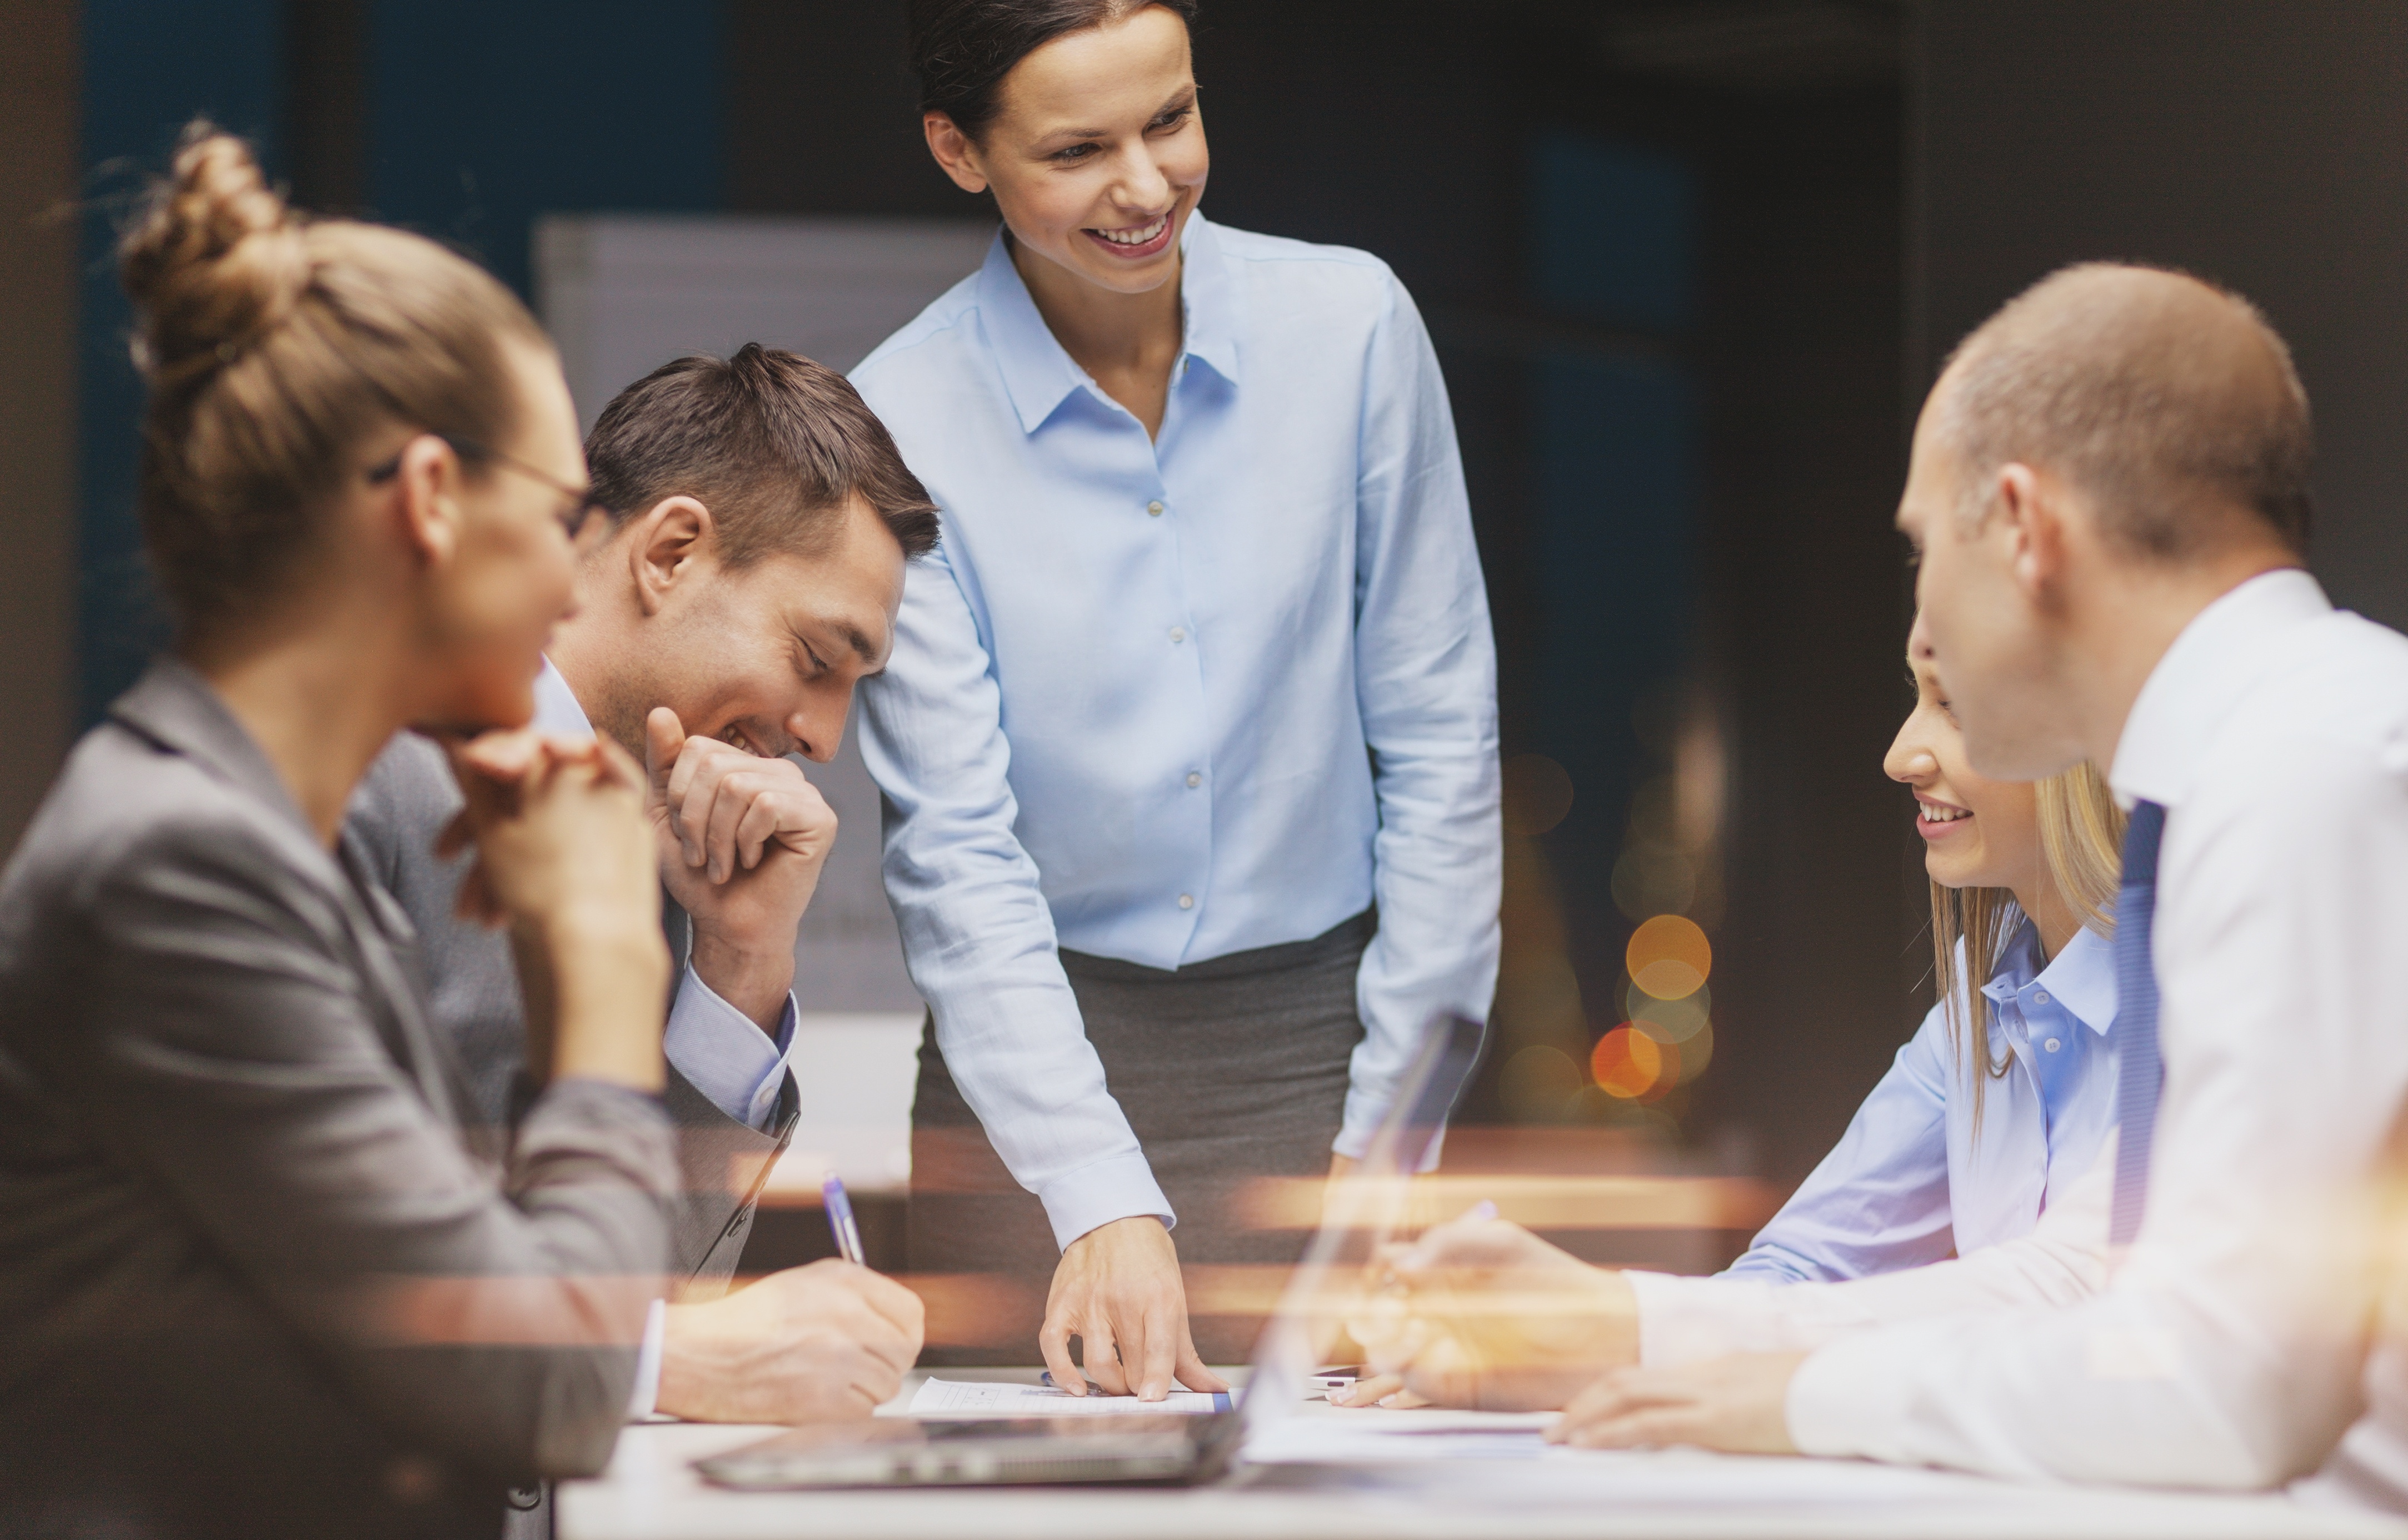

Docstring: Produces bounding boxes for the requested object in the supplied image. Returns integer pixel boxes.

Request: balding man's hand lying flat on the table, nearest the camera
[1546,1352,1806,1453]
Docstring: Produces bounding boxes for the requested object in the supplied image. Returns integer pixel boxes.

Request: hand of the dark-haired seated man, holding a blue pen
[657,1258,922,1422]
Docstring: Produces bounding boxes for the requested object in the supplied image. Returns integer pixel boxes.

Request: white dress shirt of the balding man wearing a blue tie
[1789,571,2408,1487]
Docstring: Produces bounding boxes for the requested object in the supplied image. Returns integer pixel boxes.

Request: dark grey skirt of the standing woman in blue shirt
[906,912,1377,1364]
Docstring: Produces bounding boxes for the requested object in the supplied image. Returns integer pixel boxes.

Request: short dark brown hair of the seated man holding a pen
[585,342,937,571]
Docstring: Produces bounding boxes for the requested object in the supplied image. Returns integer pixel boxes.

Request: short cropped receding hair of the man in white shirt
[1936,262,2314,561]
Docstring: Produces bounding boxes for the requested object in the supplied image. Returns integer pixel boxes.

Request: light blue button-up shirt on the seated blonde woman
[1731,922,2117,1283]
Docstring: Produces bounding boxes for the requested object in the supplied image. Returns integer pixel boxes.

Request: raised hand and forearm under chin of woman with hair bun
[438,732,670,1092]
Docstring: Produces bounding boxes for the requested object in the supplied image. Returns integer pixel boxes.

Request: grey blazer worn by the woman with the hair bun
[0,662,677,1535]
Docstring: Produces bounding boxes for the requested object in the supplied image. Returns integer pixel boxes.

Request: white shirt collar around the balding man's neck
[2107,568,2334,808]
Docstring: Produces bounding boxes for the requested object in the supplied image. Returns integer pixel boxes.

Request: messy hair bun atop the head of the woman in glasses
[118,121,308,385]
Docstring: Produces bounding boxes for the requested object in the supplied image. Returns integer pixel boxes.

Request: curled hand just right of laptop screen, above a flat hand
[1332,1218,1637,1410]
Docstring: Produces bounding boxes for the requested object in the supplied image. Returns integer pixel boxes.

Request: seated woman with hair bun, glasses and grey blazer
[0,125,677,1538]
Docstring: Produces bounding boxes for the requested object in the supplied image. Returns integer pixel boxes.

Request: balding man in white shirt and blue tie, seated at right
[1375,264,2408,1487]
